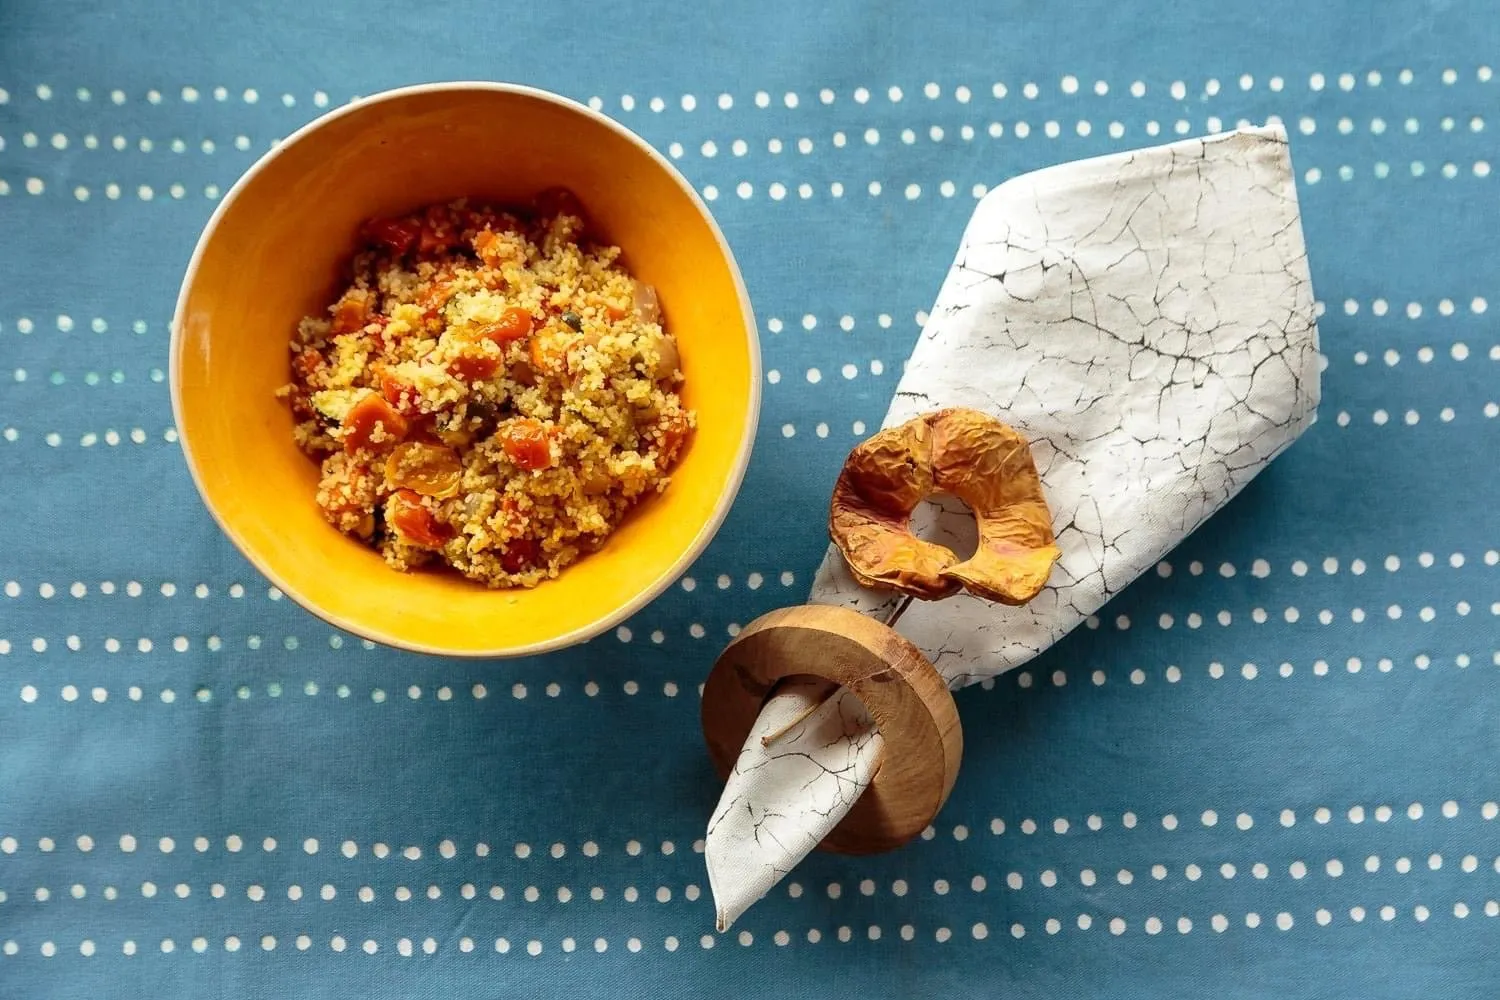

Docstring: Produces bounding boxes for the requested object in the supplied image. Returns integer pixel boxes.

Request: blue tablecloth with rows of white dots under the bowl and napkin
[0,0,1500,999]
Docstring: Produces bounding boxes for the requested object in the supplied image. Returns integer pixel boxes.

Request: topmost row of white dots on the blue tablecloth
[0,64,1494,114]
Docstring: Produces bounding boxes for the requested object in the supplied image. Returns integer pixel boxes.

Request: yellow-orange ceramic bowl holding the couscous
[171,82,761,657]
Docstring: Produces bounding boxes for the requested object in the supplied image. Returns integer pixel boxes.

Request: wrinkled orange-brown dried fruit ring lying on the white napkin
[828,408,1061,604]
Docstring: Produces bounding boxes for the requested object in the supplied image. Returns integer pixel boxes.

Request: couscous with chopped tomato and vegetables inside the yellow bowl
[282,192,695,588]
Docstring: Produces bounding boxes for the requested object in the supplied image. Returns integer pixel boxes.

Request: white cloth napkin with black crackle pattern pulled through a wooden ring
[705,126,1320,930]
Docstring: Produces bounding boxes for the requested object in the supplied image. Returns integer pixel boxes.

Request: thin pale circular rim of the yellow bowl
[168,81,764,660]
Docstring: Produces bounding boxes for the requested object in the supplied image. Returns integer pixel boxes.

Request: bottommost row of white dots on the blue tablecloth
[0,900,1500,958]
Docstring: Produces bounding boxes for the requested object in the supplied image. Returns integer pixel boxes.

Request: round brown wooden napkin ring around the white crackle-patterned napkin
[702,604,963,855]
